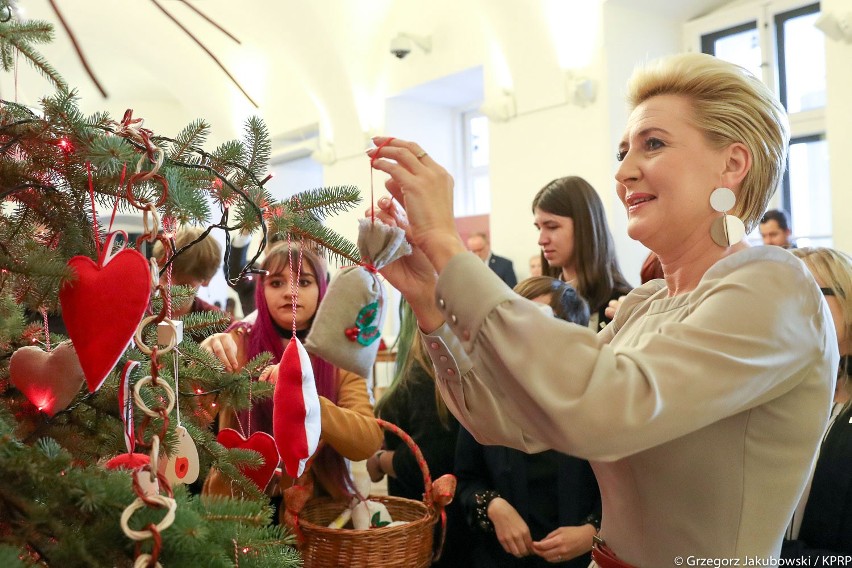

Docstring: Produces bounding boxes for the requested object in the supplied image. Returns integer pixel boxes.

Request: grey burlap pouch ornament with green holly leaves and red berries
[305,218,411,377]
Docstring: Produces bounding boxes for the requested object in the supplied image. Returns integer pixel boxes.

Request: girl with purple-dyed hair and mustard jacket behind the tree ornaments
[201,242,382,520]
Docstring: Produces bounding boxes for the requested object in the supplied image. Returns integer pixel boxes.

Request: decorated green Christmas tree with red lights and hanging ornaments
[0,8,360,567]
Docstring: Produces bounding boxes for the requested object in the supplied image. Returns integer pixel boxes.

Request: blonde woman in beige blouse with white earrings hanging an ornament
[367,53,839,567]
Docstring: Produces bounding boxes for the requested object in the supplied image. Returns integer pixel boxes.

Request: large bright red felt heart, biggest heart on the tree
[59,231,151,392]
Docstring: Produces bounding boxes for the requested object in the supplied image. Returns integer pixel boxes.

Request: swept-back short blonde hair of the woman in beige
[627,53,790,233]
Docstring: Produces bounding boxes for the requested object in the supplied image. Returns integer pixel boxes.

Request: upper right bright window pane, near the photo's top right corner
[780,12,825,113]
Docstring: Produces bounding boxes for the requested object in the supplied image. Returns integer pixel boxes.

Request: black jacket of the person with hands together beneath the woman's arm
[456,427,601,568]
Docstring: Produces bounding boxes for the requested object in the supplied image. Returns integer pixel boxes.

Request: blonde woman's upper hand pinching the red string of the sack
[367,137,465,272]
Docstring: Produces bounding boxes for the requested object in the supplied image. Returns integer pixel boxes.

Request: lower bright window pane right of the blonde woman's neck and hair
[789,140,831,246]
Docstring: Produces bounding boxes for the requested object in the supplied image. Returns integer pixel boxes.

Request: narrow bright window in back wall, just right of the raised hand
[453,111,491,217]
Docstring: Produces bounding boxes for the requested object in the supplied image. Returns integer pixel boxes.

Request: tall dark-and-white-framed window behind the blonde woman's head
[685,0,832,246]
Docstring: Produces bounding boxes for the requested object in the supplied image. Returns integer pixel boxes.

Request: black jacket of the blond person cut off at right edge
[781,405,852,559]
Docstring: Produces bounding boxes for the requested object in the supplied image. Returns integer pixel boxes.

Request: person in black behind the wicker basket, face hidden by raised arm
[367,300,470,568]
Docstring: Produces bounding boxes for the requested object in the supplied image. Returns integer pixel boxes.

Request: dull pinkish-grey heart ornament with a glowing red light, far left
[9,341,85,416]
